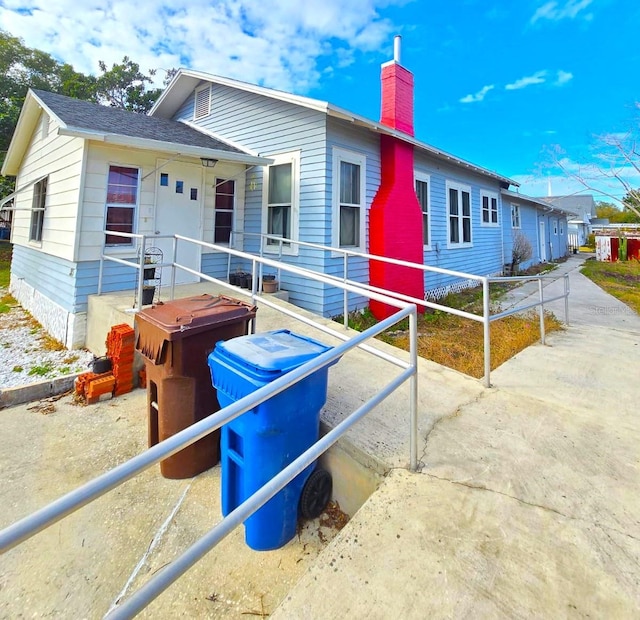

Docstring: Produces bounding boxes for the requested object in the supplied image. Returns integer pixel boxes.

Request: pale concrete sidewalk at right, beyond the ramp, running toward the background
[272,257,640,619]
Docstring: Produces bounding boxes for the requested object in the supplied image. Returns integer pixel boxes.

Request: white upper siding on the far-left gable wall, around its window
[11,111,84,260]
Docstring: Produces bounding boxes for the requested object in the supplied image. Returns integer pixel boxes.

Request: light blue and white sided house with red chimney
[2,37,567,347]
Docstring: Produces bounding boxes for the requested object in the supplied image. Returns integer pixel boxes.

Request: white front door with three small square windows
[154,162,203,286]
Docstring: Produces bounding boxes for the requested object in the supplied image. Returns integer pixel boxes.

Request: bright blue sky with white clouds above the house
[0,0,640,200]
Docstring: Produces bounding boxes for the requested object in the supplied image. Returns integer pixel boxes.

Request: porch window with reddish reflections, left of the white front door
[106,166,139,245]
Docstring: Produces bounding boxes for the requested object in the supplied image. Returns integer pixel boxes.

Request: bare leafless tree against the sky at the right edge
[555,102,640,221]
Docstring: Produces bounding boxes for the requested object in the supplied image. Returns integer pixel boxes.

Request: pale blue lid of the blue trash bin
[214,329,332,378]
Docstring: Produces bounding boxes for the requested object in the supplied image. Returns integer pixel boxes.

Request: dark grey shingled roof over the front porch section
[33,89,248,154]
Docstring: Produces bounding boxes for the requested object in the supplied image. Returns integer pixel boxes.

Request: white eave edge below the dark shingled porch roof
[59,127,273,166]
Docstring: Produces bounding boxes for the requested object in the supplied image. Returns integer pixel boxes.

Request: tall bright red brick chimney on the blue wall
[369,36,424,319]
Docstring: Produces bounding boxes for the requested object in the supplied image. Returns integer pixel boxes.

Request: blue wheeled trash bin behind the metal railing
[209,329,340,551]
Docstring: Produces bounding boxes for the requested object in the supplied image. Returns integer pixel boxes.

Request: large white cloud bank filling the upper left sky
[0,0,404,92]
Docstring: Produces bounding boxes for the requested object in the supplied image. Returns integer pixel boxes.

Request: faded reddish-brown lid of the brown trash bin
[136,293,256,340]
